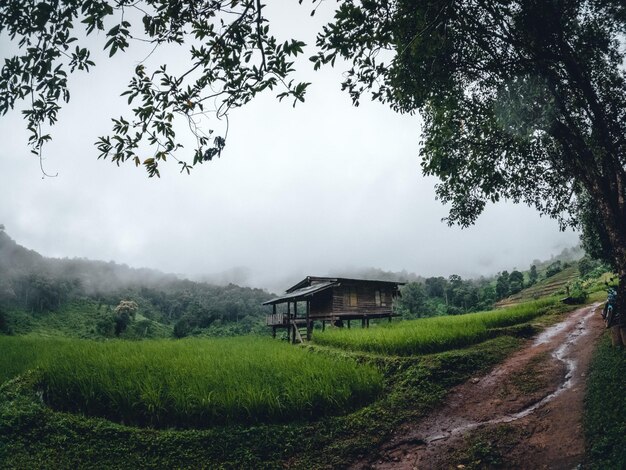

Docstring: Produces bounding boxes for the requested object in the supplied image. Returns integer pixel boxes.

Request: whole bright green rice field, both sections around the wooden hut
[0,298,558,427]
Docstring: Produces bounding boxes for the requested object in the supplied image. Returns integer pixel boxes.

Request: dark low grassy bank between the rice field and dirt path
[0,300,584,468]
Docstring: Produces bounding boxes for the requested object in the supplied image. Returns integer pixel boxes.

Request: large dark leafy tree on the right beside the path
[308,0,626,305]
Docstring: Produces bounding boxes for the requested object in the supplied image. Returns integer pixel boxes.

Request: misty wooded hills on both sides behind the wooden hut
[0,226,588,332]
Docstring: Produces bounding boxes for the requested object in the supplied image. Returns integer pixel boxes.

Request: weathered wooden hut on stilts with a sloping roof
[263,276,403,343]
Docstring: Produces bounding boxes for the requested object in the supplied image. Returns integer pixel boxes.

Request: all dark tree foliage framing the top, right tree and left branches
[0,0,626,304]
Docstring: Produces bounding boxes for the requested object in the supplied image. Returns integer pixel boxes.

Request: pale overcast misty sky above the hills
[0,0,578,290]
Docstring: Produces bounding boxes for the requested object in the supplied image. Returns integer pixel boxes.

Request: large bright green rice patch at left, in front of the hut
[0,337,382,427]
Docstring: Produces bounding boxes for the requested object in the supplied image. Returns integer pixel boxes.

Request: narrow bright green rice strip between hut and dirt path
[314,298,558,356]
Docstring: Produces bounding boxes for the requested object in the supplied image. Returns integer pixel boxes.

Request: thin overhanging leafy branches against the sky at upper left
[0,0,308,176]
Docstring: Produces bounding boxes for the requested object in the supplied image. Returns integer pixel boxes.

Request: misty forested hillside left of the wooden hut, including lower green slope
[0,230,271,336]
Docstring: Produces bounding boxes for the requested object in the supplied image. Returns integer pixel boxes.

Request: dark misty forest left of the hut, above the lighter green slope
[0,230,272,335]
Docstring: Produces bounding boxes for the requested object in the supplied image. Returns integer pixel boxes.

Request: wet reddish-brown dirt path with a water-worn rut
[353,304,604,469]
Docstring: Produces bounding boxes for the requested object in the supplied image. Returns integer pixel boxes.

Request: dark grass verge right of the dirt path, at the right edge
[583,335,626,469]
